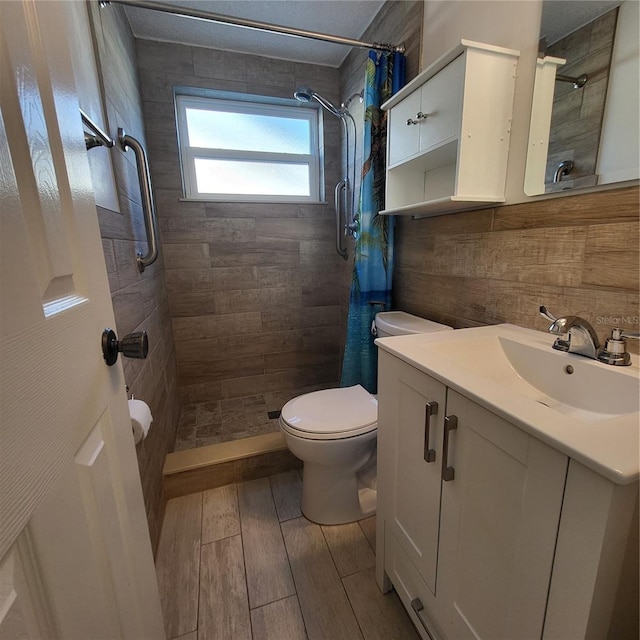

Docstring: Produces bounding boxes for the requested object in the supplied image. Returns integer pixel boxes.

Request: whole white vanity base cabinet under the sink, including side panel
[376,349,637,640]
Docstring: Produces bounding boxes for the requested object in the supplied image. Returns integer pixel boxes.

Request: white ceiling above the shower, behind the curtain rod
[125,0,388,67]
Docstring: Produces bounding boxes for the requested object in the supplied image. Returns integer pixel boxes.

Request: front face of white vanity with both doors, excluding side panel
[377,350,568,640]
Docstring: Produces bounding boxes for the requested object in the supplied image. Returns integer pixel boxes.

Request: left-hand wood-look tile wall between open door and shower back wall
[90,3,180,551]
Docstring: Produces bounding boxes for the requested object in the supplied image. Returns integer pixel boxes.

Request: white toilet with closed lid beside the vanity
[280,311,451,524]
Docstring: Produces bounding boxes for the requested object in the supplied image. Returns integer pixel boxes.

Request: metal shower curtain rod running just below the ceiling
[100,0,405,53]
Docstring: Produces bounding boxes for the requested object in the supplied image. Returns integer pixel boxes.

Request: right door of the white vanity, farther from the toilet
[437,390,568,640]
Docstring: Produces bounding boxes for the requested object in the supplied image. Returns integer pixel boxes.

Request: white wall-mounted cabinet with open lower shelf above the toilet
[382,40,519,216]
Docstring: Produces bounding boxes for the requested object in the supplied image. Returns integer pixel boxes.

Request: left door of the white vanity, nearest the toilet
[378,358,446,593]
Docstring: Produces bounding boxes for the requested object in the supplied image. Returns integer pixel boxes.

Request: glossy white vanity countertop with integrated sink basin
[376,325,640,484]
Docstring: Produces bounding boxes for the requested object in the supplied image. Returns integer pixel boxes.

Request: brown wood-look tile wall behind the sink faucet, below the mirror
[394,187,640,352]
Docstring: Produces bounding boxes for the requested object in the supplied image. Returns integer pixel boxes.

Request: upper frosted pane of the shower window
[186,109,311,154]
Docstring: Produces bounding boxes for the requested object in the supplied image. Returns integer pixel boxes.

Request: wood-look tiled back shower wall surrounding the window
[137,40,346,404]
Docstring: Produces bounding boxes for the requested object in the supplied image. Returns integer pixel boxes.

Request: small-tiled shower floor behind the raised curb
[173,386,324,451]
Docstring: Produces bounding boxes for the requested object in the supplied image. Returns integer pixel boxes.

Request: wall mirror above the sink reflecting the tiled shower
[524,0,640,196]
